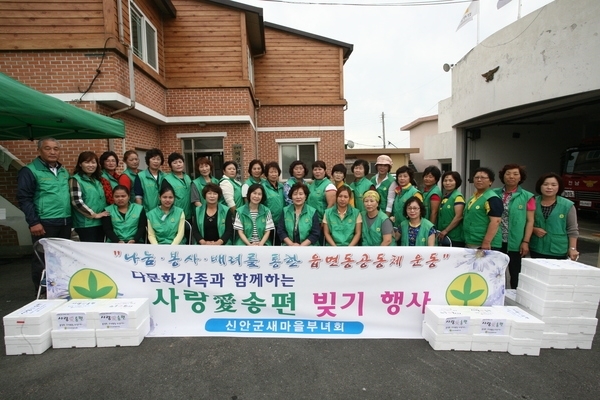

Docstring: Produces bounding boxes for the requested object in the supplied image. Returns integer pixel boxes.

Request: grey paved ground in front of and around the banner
[0,220,600,400]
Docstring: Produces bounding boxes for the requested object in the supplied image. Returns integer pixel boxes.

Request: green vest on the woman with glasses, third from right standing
[463,189,502,248]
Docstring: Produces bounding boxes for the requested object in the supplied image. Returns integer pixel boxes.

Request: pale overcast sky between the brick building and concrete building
[238,0,552,148]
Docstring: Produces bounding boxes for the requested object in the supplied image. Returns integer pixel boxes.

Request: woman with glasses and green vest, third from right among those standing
[463,167,503,251]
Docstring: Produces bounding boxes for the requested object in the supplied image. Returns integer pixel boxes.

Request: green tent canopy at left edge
[0,73,125,140]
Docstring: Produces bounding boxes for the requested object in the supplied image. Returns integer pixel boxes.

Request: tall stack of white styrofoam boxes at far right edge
[516,258,600,349]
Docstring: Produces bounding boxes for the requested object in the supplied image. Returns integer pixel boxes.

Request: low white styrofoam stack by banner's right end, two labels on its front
[422,305,510,351]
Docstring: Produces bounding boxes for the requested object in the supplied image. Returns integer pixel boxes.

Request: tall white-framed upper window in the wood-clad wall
[130,3,158,71]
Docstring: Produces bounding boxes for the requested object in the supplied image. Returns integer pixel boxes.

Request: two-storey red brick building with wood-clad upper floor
[0,0,352,252]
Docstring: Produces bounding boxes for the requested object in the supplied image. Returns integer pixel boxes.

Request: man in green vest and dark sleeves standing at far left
[17,138,72,296]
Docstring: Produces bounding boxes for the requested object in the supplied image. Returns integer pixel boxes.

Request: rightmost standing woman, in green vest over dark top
[529,172,579,261]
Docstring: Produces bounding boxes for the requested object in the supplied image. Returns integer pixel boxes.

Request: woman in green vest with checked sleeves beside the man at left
[69,151,108,242]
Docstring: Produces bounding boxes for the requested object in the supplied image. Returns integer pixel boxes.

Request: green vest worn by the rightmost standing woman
[529,196,573,257]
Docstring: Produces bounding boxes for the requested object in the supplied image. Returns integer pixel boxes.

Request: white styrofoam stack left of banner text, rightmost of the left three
[93,298,150,347]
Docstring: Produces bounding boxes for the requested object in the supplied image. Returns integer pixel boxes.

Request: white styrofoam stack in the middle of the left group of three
[52,299,110,349]
